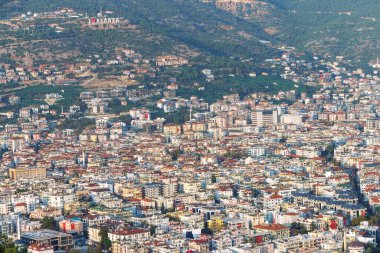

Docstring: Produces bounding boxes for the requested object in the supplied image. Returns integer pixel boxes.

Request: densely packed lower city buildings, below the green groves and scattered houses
[0,62,380,252]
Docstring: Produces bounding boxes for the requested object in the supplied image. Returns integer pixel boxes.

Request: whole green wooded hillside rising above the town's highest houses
[0,0,380,75]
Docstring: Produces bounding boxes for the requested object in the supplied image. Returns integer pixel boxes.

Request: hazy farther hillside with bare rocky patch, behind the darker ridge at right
[212,0,380,63]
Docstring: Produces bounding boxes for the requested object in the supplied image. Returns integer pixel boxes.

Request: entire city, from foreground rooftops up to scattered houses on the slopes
[0,2,380,253]
